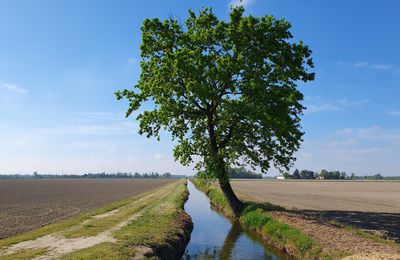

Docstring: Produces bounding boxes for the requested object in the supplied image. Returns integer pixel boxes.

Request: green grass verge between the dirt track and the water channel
[61,181,189,260]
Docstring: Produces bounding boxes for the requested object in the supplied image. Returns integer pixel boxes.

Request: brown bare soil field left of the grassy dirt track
[0,179,174,239]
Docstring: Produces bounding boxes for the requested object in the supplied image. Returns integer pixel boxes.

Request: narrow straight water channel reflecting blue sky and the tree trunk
[183,181,290,260]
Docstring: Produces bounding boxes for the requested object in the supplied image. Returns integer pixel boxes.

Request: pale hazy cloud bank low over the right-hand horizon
[295,126,400,175]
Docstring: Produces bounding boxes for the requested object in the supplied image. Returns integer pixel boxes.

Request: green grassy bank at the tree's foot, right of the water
[193,179,340,259]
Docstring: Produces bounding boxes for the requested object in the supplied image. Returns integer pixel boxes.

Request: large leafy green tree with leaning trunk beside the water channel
[116,7,314,214]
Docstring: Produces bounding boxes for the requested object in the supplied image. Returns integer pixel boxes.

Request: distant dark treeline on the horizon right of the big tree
[283,169,400,180]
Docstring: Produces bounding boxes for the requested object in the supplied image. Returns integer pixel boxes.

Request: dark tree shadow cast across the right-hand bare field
[300,210,400,243]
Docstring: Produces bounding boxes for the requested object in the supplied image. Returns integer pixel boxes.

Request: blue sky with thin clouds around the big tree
[0,0,400,175]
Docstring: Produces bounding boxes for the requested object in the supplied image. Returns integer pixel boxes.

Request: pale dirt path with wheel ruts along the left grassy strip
[0,182,175,260]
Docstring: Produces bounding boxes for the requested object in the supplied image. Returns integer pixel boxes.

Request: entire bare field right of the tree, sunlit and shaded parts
[232,180,400,242]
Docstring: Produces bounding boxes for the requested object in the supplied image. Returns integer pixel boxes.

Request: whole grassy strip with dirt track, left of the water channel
[0,181,192,259]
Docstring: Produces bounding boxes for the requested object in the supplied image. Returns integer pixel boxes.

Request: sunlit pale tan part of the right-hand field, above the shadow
[232,181,400,213]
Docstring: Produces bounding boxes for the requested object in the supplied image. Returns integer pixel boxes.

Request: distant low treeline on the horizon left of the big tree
[0,172,186,179]
